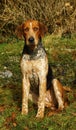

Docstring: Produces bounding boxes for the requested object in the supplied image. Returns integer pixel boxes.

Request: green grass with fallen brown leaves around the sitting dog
[0,36,76,130]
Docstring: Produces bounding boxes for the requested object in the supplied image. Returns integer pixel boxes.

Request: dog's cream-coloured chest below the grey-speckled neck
[21,56,48,94]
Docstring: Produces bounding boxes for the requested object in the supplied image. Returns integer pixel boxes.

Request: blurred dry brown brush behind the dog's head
[0,0,76,43]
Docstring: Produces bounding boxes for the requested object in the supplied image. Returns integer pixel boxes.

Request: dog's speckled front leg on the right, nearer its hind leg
[36,77,46,118]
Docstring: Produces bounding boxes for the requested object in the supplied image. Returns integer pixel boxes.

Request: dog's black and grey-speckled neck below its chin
[22,42,46,60]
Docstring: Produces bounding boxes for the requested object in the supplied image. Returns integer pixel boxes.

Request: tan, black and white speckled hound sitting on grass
[16,20,69,118]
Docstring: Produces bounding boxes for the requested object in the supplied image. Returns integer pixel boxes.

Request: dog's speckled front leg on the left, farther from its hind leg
[22,75,30,115]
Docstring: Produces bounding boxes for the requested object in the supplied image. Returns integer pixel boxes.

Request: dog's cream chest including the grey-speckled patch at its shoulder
[21,48,48,92]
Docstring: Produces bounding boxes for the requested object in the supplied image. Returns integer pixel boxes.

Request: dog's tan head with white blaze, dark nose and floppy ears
[16,20,47,47]
